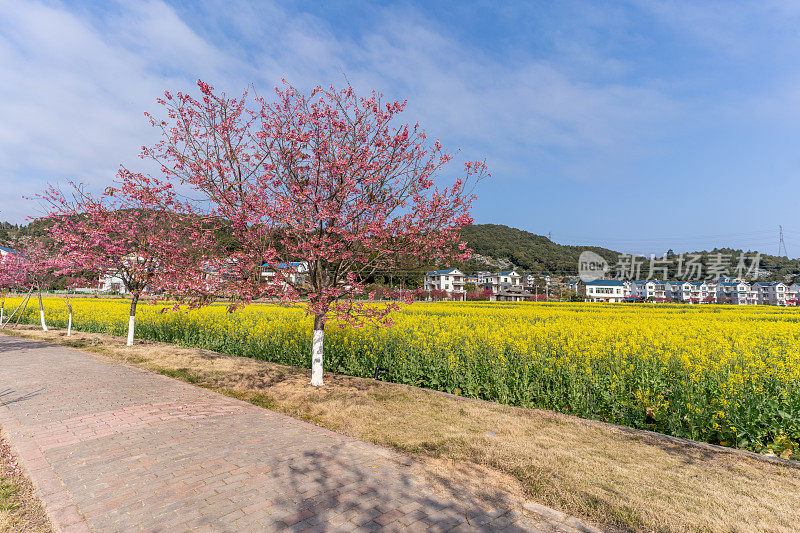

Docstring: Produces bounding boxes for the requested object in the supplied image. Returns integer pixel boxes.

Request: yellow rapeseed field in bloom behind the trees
[6,298,800,457]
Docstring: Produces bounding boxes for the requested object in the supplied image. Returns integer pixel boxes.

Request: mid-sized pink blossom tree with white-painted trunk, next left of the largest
[40,170,213,346]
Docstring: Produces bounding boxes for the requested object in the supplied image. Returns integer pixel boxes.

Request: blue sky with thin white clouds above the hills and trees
[0,0,800,256]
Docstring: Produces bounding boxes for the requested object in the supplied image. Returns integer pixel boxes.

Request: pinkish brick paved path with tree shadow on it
[0,335,594,532]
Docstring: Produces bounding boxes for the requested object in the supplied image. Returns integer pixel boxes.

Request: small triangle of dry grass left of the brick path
[0,435,53,533]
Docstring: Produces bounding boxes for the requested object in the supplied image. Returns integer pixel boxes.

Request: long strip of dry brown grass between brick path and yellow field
[6,329,800,532]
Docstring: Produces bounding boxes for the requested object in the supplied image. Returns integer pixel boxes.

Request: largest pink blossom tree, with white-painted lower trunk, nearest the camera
[142,81,488,386]
